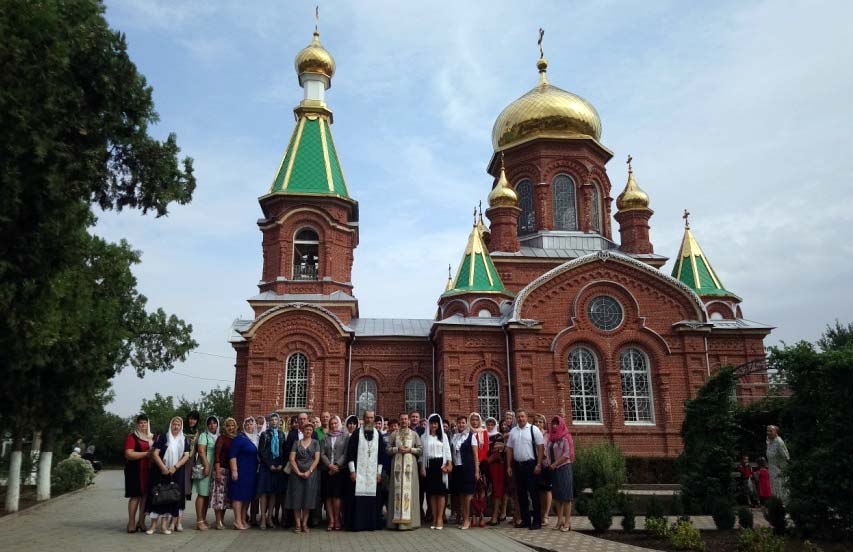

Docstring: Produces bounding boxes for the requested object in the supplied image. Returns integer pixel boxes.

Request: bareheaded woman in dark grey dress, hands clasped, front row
[284,422,320,533]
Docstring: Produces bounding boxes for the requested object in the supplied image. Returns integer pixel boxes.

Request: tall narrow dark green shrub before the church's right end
[677,367,737,513]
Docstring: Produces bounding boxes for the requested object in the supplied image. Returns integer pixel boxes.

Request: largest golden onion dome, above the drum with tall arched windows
[492,57,601,151]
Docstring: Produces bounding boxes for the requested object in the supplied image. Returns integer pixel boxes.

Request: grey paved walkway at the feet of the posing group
[0,471,664,552]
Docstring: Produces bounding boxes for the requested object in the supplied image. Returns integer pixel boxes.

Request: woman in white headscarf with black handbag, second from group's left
[146,416,190,535]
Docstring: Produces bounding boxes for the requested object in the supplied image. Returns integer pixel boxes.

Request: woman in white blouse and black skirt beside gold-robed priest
[420,414,453,529]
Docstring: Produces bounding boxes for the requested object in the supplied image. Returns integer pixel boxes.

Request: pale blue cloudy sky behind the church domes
[95,0,853,415]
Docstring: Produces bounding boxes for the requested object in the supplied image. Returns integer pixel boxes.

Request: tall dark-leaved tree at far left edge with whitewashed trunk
[0,0,195,511]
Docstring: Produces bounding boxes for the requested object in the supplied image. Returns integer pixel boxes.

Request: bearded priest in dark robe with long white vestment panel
[347,410,386,531]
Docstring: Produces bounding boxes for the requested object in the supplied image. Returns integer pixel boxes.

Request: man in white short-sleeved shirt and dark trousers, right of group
[506,409,545,529]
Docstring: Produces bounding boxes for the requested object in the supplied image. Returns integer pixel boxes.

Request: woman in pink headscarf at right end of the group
[542,416,575,533]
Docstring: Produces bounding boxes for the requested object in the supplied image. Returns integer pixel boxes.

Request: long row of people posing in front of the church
[125,409,574,534]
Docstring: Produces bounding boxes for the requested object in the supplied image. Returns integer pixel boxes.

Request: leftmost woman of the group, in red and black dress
[124,414,154,533]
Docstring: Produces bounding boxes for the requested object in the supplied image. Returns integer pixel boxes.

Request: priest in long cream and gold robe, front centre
[387,414,423,531]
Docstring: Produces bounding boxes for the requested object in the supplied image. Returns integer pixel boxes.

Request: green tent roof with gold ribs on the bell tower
[270,113,349,197]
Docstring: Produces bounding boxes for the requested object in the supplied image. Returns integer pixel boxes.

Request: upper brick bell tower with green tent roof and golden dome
[249,21,358,323]
